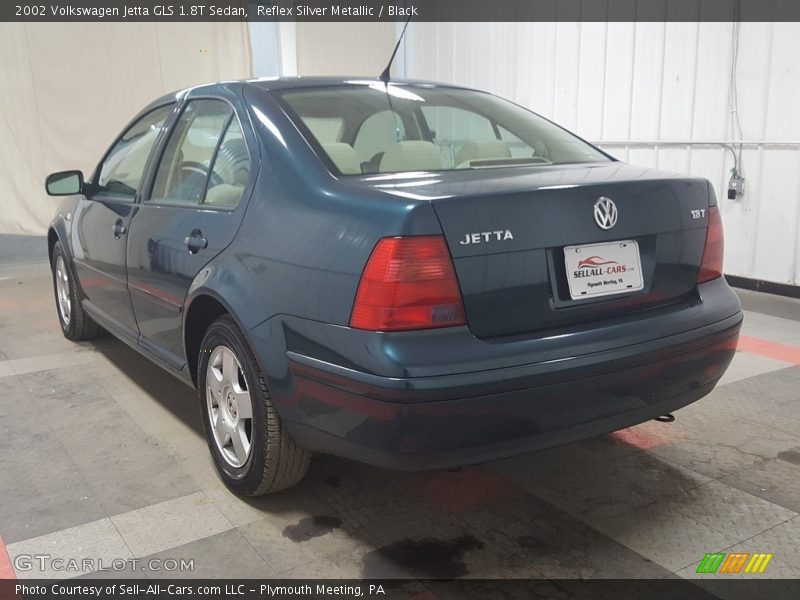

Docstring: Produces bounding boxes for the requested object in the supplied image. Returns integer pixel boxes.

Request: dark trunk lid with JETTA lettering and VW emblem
[360,162,710,338]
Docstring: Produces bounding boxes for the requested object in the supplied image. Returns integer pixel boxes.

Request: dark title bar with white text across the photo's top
[0,0,800,22]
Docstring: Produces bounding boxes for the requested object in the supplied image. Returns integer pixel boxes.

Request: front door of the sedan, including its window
[71,103,174,339]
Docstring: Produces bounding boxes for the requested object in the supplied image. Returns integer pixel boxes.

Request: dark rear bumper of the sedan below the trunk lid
[255,279,742,470]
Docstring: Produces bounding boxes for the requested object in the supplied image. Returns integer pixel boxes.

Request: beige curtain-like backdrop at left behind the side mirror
[0,22,252,235]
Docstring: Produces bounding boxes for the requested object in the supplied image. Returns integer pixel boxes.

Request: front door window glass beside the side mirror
[96,104,174,201]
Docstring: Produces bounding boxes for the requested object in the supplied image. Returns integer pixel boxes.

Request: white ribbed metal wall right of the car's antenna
[404,22,800,284]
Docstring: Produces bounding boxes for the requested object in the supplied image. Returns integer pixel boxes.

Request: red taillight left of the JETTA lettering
[350,235,464,331]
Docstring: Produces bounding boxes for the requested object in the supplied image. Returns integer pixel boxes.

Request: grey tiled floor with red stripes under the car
[0,255,800,597]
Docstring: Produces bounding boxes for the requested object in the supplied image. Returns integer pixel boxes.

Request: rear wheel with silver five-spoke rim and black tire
[197,316,311,496]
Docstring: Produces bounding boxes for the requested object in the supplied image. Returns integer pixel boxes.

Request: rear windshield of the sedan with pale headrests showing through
[278,82,609,175]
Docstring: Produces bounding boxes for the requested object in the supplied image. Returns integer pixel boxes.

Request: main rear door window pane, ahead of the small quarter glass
[150,100,233,206]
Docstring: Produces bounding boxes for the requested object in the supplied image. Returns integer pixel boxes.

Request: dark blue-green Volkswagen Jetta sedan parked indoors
[47,78,742,495]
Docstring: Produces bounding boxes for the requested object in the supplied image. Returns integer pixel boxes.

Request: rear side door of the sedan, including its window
[127,98,253,369]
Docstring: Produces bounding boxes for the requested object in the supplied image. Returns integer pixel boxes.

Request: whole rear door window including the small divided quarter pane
[150,100,250,208]
